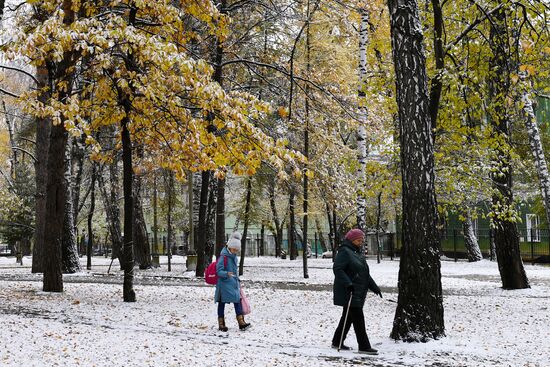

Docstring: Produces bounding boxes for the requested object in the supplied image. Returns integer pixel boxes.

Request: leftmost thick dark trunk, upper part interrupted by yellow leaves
[32,67,51,273]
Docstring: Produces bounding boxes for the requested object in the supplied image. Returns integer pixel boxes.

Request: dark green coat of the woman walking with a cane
[332,239,380,307]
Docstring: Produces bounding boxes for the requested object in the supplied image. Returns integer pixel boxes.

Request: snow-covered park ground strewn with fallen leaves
[0,256,550,367]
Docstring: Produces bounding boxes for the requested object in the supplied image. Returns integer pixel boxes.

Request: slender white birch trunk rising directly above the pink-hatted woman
[357,9,369,230]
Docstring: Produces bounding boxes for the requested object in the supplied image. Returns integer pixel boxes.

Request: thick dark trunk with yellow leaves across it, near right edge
[488,6,529,289]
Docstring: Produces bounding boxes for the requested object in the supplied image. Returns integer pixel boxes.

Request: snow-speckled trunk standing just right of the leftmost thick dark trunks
[61,139,81,274]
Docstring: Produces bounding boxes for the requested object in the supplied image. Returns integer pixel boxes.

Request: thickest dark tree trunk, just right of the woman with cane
[388,0,445,342]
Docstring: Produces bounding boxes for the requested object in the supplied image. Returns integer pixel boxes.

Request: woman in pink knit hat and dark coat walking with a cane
[332,229,382,354]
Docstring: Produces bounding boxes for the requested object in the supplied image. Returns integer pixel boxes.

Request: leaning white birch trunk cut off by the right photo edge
[521,78,550,228]
